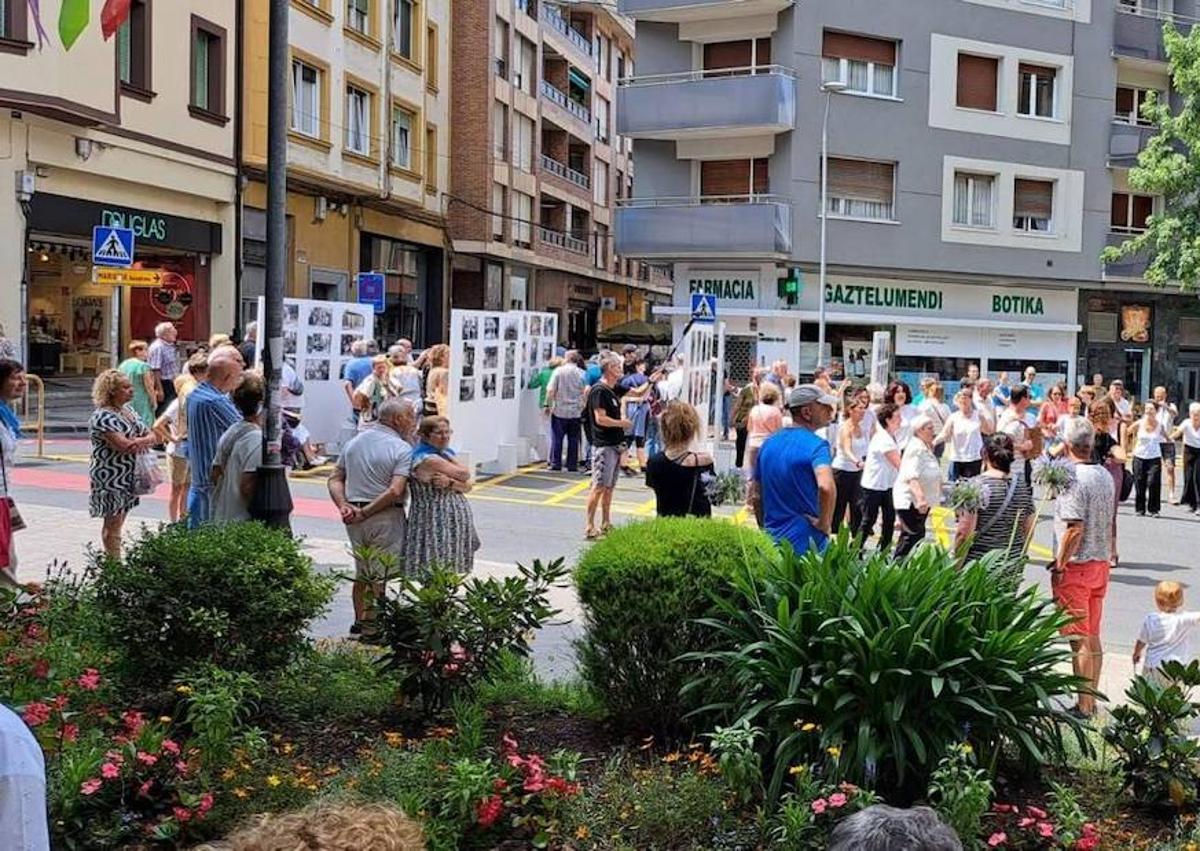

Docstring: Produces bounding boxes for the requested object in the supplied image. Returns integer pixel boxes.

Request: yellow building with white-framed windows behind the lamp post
[239,0,451,346]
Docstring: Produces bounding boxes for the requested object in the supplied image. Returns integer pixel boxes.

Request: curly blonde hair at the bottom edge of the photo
[229,804,425,851]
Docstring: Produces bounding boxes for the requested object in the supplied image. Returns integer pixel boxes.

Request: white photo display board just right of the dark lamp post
[256,296,374,450]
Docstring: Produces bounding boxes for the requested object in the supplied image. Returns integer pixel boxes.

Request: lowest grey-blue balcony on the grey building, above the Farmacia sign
[613,194,792,259]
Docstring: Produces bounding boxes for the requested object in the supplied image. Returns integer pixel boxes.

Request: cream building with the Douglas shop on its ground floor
[0,0,236,374]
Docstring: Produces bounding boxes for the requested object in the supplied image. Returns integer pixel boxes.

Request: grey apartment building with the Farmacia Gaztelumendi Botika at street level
[614,0,1200,398]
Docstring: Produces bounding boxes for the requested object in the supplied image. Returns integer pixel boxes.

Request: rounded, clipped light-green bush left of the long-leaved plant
[575,517,778,731]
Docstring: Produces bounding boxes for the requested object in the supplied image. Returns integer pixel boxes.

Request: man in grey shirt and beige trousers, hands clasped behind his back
[329,398,414,635]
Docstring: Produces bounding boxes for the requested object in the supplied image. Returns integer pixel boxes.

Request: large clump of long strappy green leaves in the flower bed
[689,534,1087,801]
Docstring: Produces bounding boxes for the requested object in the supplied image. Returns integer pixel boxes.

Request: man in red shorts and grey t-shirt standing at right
[1051,419,1115,718]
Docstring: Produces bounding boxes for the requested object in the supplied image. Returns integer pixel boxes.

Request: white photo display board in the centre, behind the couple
[448,310,558,469]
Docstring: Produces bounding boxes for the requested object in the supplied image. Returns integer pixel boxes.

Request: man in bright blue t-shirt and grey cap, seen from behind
[750,384,838,552]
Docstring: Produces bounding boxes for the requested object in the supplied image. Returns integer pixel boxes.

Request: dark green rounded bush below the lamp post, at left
[96,523,334,688]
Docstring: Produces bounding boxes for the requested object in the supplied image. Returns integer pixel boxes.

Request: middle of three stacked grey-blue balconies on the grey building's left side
[617,65,796,139]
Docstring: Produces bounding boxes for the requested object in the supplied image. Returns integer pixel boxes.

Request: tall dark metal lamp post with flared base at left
[250,0,292,528]
